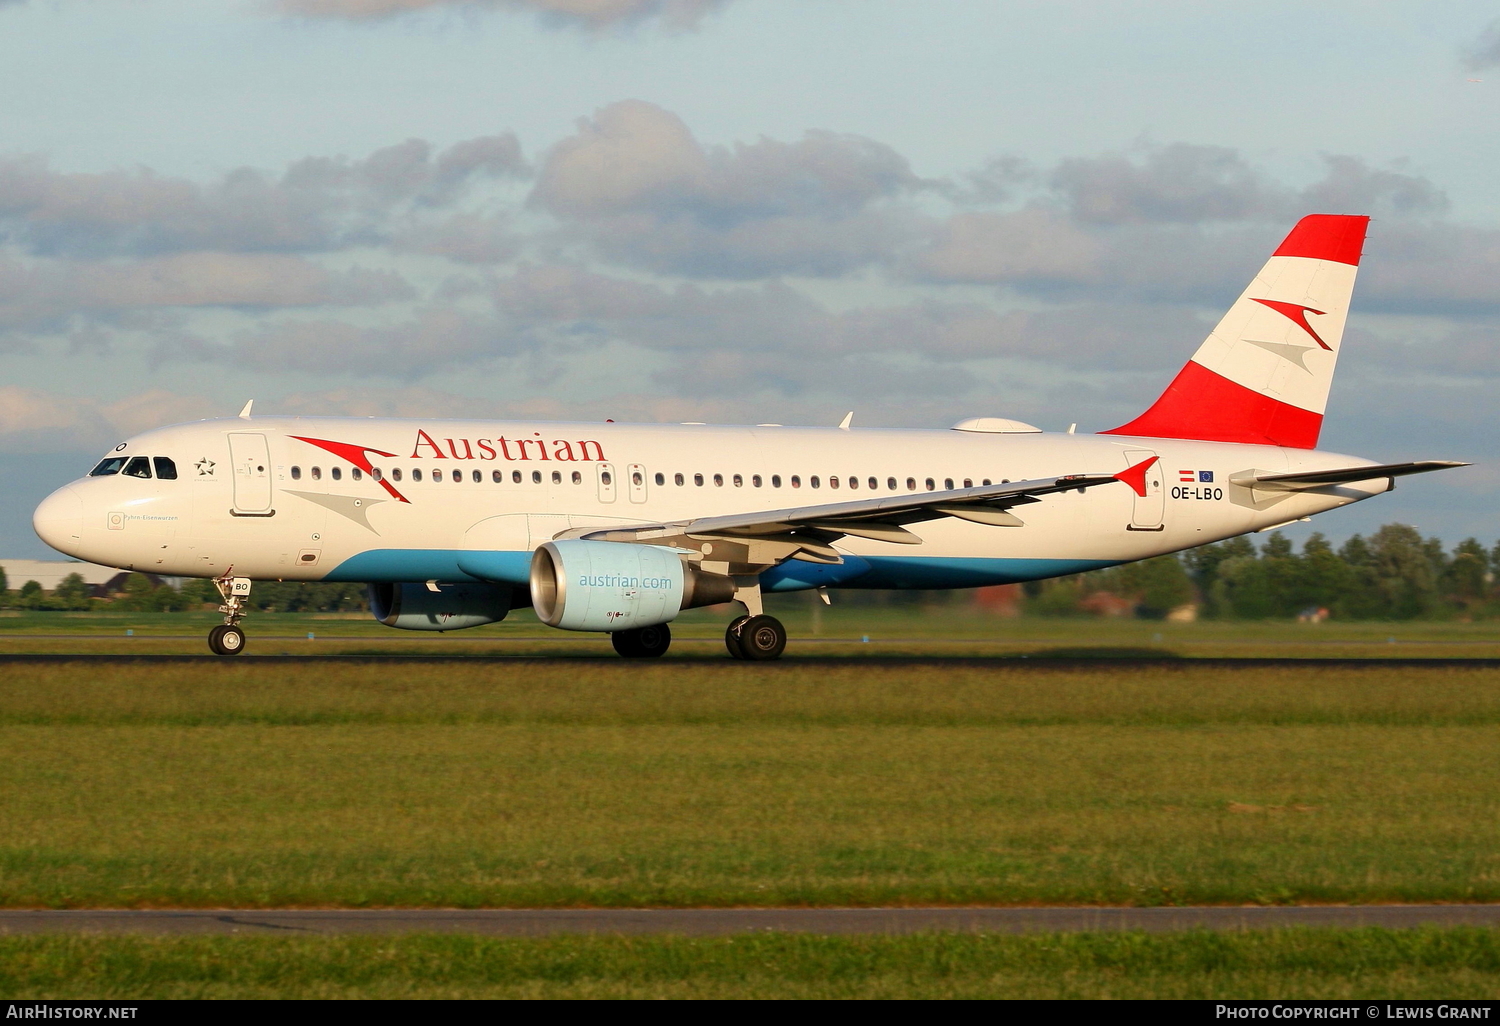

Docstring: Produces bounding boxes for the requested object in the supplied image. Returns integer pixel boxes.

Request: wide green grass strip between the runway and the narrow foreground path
[0,660,1500,908]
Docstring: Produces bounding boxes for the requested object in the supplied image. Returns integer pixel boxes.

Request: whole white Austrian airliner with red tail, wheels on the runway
[33,215,1466,660]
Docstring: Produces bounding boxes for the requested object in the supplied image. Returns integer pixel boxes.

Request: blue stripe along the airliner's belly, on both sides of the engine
[334,549,1118,591]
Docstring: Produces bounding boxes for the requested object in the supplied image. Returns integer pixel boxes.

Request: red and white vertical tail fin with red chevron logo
[1101,215,1370,449]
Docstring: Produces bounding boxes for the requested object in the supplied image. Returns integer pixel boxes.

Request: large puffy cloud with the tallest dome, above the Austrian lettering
[531,101,932,278]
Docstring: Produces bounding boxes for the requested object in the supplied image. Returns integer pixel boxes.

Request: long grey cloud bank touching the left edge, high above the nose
[0,132,530,258]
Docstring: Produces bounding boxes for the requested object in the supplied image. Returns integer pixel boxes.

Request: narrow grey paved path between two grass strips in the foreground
[0,905,1500,938]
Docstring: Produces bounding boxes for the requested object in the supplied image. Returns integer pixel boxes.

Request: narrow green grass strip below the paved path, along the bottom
[0,929,1500,1001]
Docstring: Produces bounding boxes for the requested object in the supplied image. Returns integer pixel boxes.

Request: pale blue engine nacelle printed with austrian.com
[531,540,735,632]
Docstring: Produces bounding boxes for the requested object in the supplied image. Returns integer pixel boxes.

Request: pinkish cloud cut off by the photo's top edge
[272,0,729,30]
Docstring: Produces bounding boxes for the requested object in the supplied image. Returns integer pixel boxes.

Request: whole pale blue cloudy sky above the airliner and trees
[0,0,1500,555]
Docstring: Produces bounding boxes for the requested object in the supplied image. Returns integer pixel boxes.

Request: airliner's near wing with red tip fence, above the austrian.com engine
[563,465,1145,564]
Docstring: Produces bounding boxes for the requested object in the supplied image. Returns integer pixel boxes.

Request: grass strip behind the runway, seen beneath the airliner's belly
[0,609,1500,659]
